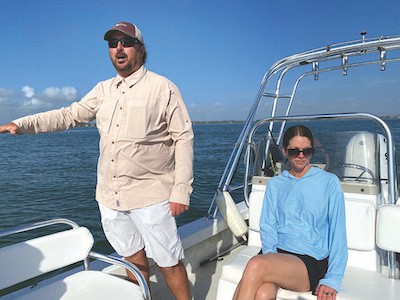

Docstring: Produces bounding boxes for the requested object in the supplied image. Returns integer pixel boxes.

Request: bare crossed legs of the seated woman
[233,253,310,300]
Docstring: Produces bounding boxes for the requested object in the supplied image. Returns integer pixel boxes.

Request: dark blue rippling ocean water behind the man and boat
[0,119,400,253]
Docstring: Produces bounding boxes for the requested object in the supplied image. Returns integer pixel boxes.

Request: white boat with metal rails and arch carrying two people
[0,33,400,300]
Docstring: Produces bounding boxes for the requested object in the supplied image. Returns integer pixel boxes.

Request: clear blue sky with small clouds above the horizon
[0,0,400,123]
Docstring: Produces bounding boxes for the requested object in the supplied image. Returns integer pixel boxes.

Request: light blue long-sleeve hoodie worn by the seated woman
[260,167,347,291]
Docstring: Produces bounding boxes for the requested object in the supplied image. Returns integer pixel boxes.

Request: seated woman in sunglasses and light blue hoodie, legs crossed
[233,125,347,300]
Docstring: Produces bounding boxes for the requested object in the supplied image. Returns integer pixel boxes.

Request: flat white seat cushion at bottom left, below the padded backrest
[16,271,144,300]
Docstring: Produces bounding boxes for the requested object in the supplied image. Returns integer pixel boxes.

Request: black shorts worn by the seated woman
[277,249,328,293]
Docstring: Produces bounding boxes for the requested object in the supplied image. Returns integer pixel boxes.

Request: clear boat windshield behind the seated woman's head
[253,131,387,184]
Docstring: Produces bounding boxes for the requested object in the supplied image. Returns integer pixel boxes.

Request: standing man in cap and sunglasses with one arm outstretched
[0,22,193,299]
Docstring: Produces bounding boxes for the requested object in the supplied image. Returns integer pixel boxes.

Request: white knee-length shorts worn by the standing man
[99,200,184,267]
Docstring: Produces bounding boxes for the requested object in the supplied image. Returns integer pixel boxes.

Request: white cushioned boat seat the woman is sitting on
[217,178,400,300]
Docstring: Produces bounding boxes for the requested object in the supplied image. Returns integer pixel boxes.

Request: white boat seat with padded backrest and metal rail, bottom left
[0,219,149,300]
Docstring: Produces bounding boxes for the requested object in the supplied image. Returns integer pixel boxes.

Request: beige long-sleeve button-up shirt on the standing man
[13,66,193,210]
